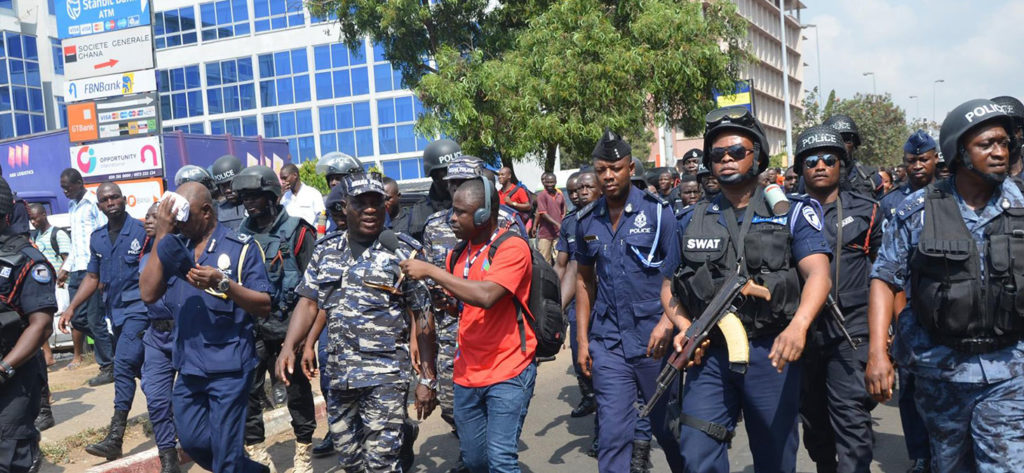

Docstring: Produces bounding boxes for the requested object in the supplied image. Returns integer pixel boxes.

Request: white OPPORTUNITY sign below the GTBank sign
[71,136,164,183]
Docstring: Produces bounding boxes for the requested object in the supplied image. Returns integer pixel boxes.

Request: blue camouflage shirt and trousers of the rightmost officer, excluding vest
[871,176,1024,472]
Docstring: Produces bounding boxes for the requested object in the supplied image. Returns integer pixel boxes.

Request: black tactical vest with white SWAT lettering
[673,193,800,338]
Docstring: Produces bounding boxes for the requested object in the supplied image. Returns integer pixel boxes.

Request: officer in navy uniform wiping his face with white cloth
[140,182,273,472]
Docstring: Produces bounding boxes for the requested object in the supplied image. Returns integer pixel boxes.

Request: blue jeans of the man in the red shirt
[455,363,537,473]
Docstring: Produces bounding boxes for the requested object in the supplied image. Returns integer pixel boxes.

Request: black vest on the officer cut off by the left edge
[0,234,32,357]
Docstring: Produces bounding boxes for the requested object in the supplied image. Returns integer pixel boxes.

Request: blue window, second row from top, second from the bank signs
[206,57,256,115]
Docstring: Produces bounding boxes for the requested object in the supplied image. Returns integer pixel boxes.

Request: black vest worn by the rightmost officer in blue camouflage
[910,179,1024,353]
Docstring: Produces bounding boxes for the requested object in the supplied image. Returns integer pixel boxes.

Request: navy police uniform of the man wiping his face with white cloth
[158,224,273,472]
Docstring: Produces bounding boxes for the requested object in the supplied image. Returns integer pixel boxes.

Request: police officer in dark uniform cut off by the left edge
[0,178,57,473]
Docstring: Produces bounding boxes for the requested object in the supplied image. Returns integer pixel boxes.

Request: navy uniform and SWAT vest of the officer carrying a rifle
[663,187,831,473]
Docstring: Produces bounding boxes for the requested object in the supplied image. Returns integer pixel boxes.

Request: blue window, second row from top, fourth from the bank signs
[313,43,370,100]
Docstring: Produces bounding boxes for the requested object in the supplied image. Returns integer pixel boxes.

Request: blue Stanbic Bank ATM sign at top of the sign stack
[53,0,150,39]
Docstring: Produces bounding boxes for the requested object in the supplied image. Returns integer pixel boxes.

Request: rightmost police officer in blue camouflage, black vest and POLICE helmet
[866,99,1024,473]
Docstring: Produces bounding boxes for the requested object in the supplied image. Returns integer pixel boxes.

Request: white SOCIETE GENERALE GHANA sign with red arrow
[60,27,153,80]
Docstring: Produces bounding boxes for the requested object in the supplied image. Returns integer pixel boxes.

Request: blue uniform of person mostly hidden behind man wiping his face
[138,253,177,449]
